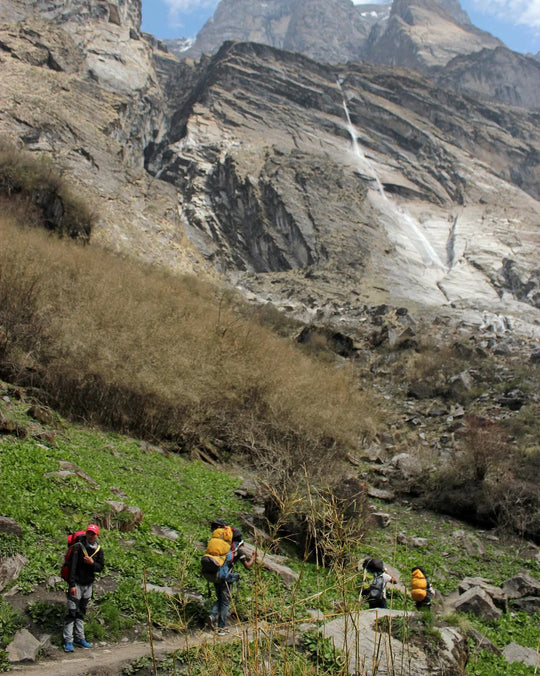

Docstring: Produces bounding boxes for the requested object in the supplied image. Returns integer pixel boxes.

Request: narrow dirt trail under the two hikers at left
[11,627,251,676]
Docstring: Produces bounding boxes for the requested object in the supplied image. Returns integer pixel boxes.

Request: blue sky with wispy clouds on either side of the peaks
[142,0,540,54]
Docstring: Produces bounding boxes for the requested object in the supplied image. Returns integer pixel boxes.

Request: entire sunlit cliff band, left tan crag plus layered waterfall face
[0,0,540,334]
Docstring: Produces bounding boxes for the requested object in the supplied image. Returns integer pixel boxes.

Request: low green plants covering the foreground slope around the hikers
[0,390,540,676]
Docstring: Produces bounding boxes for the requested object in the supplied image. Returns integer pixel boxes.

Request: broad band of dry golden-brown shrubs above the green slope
[0,217,373,476]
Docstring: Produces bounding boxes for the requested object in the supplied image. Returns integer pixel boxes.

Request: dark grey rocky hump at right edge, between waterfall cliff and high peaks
[434,47,540,110]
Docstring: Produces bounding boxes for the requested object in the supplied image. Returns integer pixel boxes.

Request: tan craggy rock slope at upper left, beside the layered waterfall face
[0,10,208,269]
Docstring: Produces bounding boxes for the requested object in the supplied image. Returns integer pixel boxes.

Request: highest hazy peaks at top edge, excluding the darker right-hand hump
[187,0,501,70]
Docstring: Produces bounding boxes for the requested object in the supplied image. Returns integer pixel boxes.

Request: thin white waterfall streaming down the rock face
[338,80,448,272]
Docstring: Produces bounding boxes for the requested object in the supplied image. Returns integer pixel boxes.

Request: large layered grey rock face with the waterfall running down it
[147,43,540,330]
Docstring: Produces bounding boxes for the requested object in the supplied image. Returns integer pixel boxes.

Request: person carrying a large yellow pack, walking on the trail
[201,520,257,636]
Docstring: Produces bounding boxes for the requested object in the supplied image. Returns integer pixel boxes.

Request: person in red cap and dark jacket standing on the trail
[63,524,105,653]
